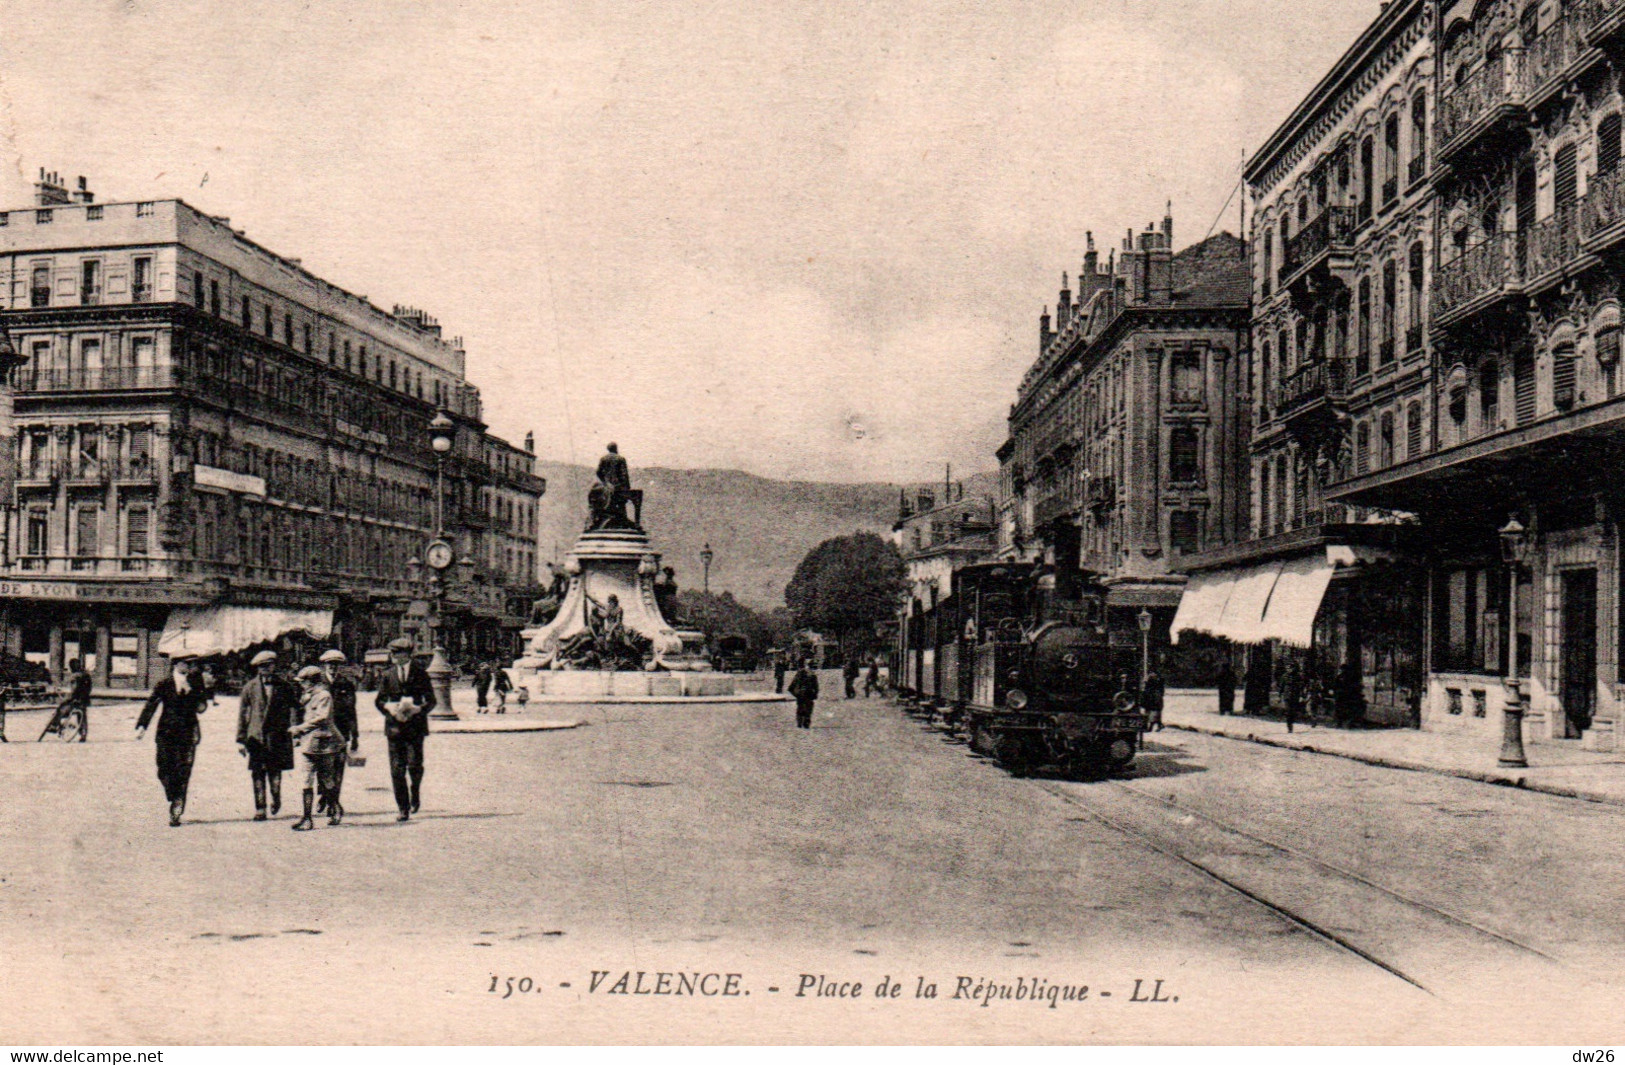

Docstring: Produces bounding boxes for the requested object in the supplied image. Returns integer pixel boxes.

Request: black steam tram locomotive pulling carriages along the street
[904,563,1147,774]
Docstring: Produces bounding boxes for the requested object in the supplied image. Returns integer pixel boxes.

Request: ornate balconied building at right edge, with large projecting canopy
[1336,0,1625,748]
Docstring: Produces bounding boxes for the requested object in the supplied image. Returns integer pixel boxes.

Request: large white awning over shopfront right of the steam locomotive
[1173,550,1336,647]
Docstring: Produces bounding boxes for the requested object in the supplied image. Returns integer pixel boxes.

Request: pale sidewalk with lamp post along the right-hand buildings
[1162,688,1625,806]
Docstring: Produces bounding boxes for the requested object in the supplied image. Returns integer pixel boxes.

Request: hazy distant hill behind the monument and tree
[536,462,998,610]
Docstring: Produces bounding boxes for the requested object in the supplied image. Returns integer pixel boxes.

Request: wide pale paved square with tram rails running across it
[0,676,1625,1044]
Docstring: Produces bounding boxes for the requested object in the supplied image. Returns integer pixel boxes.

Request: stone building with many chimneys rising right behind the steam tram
[998,218,1250,676]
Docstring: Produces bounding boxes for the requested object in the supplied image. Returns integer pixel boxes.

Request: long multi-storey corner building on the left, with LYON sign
[0,174,544,688]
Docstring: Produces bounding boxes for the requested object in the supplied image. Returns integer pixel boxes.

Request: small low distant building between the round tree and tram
[892,480,998,694]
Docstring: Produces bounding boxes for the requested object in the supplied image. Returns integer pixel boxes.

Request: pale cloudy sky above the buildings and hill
[0,0,1378,481]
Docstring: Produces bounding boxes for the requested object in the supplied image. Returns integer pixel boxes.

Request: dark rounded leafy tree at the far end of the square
[785,532,904,650]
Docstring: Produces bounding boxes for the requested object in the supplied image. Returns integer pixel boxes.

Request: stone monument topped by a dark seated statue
[512,444,733,701]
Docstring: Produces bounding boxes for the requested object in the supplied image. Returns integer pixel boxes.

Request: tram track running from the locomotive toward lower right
[1034,770,1560,998]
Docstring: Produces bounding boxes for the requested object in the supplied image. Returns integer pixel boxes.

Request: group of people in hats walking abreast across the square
[135,637,436,832]
